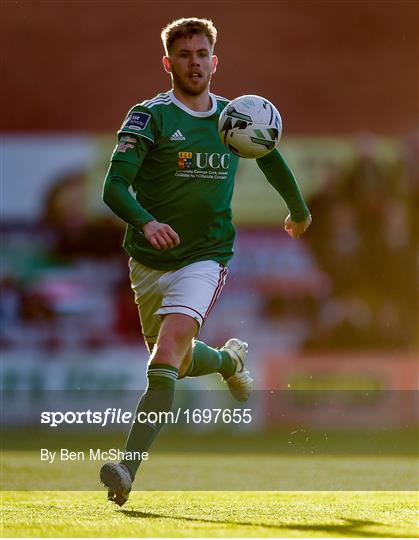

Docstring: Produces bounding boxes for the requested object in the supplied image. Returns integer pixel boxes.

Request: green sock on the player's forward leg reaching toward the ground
[121,364,178,478]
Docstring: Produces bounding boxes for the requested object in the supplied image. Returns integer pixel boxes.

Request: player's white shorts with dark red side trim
[129,258,228,348]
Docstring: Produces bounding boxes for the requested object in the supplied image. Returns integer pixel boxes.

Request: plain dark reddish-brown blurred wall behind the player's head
[0,0,419,134]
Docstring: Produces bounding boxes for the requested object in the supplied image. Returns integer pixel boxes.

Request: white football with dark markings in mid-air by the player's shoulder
[218,95,282,159]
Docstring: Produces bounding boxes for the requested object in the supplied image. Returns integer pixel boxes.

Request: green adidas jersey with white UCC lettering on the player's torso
[112,92,238,270]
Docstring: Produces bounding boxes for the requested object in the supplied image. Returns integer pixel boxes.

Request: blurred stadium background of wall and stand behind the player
[0,0,419,448]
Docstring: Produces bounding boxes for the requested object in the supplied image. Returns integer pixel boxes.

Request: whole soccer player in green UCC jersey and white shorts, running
[100,18,311,506]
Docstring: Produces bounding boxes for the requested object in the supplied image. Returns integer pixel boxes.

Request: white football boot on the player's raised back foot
[221,338,253,401]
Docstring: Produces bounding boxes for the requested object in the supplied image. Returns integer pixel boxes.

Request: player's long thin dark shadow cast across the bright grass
[120,510,400,538]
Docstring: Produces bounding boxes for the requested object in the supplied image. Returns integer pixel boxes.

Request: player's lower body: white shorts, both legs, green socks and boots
[101,260,252,506]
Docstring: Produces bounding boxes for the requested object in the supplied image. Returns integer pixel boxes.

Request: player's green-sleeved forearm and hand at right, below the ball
[256,150,311,238]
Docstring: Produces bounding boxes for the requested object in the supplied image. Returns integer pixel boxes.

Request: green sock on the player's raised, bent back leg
[186,340,236,379]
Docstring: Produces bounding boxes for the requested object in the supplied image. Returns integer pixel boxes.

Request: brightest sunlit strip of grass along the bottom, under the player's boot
[2,491,418,538]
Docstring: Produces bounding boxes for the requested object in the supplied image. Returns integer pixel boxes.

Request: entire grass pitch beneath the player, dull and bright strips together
[1,433,419,538]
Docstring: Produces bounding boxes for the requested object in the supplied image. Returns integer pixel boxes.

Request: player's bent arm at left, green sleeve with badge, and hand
[103,132,180,249]
